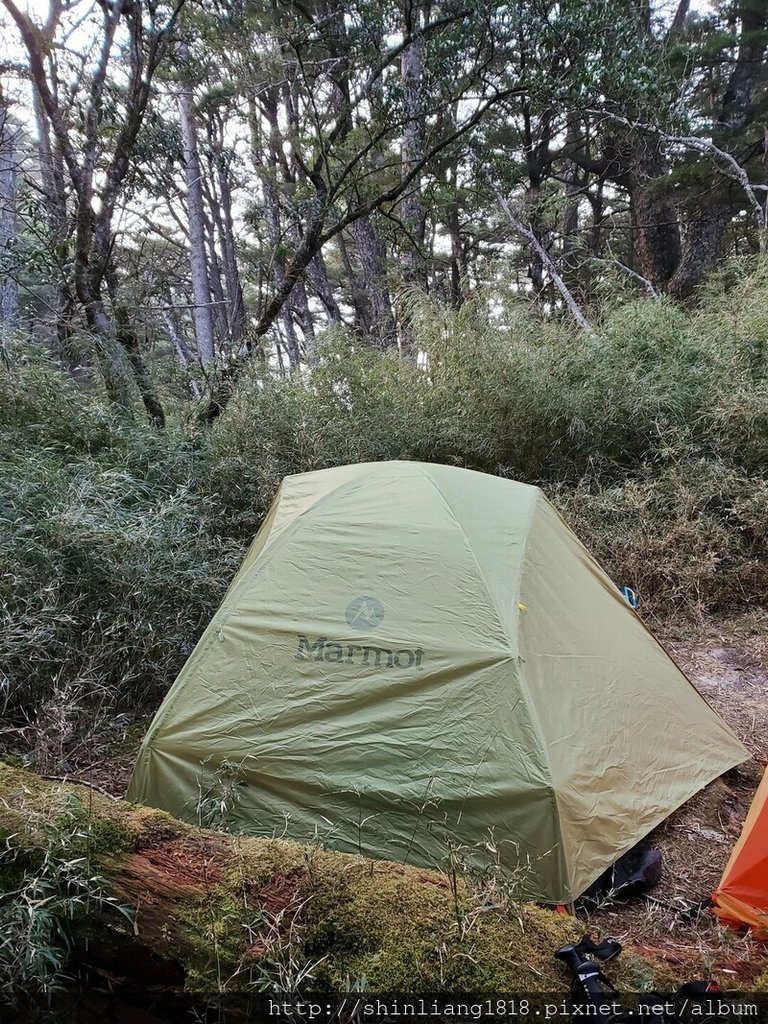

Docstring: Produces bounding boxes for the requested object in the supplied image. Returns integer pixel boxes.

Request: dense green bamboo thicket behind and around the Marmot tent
[0,263,768,724]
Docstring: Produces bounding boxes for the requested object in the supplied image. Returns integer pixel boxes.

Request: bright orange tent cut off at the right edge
[712,771,768,939]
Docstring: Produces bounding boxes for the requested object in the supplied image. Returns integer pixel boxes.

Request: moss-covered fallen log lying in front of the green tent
[0,763,671,1015]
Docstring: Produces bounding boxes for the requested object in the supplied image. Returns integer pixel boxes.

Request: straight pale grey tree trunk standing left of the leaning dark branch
[178,54,216,364]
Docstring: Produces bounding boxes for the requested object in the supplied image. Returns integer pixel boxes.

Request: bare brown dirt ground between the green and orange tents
[581,616,768,989]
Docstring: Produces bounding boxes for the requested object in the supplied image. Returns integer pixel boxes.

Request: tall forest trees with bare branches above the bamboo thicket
[0,0,768,411]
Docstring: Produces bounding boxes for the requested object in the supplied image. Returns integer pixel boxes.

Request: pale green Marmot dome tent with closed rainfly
[129,462,749,902]
